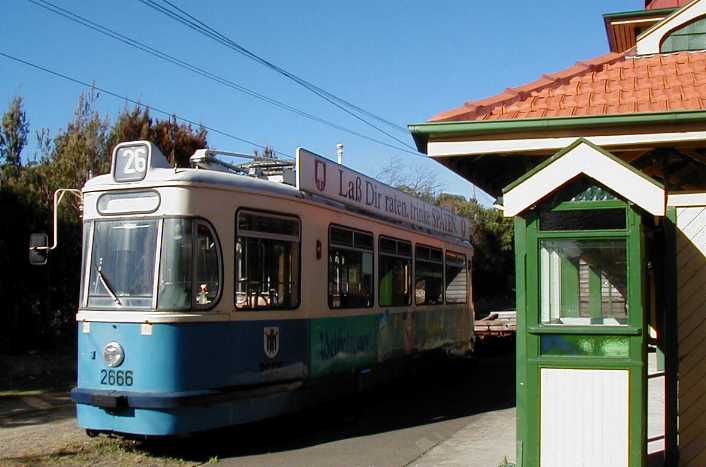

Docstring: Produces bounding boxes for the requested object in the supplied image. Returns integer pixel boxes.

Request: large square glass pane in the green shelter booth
[539,239,628,325]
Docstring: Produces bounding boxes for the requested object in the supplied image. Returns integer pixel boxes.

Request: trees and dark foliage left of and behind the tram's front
[0,90,206,352]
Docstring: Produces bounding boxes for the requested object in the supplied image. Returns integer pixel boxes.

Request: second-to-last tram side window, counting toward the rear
[414,245,444,305]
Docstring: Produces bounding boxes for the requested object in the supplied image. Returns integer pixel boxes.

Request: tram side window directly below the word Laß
[328,226,373,308]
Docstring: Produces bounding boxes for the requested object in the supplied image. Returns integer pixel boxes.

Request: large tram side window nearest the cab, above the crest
[235,211,300,311]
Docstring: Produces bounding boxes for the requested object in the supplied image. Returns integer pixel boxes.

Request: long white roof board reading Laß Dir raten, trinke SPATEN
[297,148,469,240]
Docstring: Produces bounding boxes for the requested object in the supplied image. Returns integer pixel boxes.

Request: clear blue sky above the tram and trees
[0,0,644,203]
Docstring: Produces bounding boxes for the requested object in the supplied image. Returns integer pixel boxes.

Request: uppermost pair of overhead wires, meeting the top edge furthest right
[139,0,415,151]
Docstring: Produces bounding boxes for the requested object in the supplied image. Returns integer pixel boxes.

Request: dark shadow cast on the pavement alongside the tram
[139,344,515,462]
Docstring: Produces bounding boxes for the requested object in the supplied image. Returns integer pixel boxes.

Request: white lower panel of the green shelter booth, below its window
[540,368,630,467]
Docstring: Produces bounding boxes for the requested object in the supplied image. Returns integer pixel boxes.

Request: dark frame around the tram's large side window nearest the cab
[233,207,302,313]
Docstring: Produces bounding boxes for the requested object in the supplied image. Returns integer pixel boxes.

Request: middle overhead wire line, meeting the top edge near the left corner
[28,0,420,157]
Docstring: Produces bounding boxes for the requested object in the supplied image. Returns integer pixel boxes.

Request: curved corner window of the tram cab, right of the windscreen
[157,218,221,310]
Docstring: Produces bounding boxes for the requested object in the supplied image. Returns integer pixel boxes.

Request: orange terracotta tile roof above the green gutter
[430,51,706,122]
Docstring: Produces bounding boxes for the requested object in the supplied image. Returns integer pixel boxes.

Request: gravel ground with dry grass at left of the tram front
[0,349,193,467]
